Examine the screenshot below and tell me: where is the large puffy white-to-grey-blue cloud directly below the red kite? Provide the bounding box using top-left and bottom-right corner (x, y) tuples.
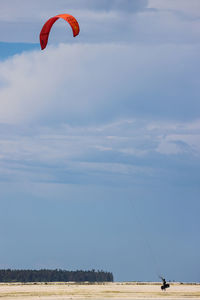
(0, 44), (199, 124)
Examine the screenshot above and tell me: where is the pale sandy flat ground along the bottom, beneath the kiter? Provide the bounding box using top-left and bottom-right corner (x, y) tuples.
(0, 282), (200, 300)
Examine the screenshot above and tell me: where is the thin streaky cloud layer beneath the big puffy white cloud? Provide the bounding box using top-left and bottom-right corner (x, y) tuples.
(0, 119), (200, 183)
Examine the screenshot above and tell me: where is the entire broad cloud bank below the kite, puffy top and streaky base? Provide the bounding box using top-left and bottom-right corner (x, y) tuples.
(0, 44), (200, 185)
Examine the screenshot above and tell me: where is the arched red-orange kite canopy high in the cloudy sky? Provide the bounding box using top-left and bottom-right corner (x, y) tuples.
(40, 14), (80, 50)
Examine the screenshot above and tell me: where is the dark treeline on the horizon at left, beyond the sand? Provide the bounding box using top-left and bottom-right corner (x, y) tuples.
(0, 269), (114, 282)
